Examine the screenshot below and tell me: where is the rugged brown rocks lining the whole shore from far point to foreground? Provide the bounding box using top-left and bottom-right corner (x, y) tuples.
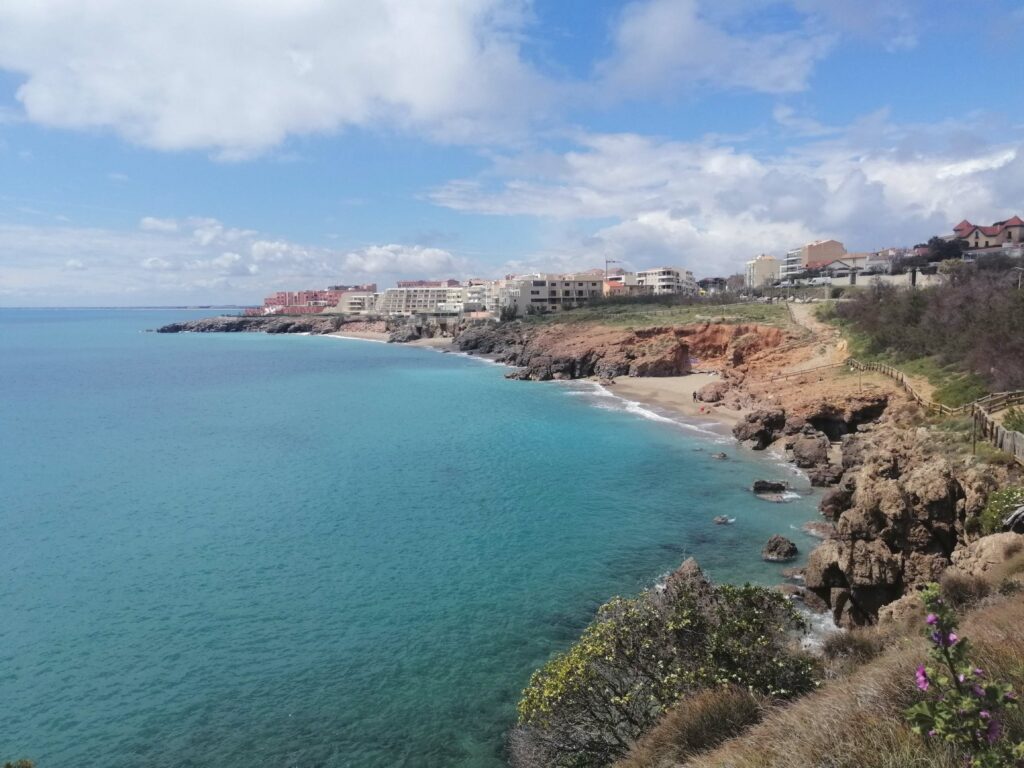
(158, 315), (1013, 628)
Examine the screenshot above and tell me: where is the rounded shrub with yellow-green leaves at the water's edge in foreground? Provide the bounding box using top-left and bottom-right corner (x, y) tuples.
(511, 567), (817, 768)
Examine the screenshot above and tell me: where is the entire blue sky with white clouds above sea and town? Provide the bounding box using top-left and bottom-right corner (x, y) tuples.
(0, 0), (1024, 306)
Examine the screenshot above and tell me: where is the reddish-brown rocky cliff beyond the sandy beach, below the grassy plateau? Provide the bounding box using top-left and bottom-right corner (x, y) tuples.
(456, 323), (785, 381)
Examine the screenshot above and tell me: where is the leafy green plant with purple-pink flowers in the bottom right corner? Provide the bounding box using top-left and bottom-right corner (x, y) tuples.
(906, 585), (1024, 768)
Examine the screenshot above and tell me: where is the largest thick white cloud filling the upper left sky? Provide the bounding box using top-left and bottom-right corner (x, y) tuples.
(0, 0), (548, 158)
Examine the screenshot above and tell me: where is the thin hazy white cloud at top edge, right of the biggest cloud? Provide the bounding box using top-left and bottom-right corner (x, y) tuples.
(598, 0), (831, 95)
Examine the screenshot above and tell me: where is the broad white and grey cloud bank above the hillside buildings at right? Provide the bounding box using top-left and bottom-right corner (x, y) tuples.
(432, 115), (1024, 274)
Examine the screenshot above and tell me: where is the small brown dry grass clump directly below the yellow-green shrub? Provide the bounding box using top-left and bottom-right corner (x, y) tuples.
(615, 688), (762, 768)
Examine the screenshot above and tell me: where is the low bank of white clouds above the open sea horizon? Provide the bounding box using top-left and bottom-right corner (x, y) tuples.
(0, 218), (465, 306)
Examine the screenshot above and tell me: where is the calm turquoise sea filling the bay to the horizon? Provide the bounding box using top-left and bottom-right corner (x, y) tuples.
(0, 310), (815, 768)
